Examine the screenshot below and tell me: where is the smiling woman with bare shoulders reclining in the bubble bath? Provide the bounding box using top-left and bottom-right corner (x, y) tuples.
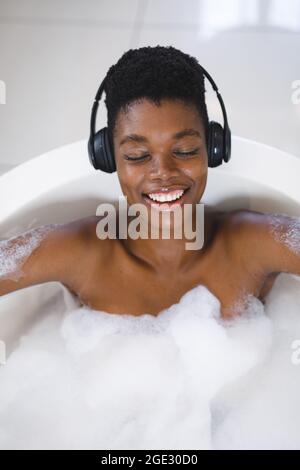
(0, 46), (300, 318)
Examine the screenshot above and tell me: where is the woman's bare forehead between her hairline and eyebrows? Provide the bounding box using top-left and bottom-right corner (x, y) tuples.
(115, 99), (202, 140)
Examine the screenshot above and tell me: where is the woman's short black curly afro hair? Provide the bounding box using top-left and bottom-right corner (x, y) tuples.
(104, 46), (209, 148)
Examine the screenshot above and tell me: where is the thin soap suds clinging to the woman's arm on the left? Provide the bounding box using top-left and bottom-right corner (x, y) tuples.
(0, 224), (57, 281)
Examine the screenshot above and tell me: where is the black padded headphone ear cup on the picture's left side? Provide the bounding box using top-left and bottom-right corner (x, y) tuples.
(89, 127), (116, 173)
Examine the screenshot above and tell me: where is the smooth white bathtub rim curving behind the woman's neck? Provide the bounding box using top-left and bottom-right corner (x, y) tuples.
(0, 136), (300, 222)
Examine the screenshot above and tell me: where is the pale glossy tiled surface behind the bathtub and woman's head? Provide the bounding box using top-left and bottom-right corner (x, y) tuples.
(0, 0), (300, 172)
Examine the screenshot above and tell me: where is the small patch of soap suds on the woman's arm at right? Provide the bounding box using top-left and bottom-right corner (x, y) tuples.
(270, 214), (300, 255)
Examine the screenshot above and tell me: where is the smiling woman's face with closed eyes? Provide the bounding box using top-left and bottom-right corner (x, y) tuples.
(114, 99), (207, 208)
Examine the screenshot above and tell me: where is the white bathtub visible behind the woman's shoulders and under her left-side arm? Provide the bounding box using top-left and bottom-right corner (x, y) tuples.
(0, 137), (300, 353)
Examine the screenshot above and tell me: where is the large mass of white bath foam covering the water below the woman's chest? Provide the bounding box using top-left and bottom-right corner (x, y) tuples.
(0, 273), (300, 449)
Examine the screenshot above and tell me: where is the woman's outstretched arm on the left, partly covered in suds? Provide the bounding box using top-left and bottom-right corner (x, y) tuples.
(0, 220), (88, 296)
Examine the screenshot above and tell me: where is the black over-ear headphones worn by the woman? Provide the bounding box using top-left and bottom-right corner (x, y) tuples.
(88, 65), (231, 173)
